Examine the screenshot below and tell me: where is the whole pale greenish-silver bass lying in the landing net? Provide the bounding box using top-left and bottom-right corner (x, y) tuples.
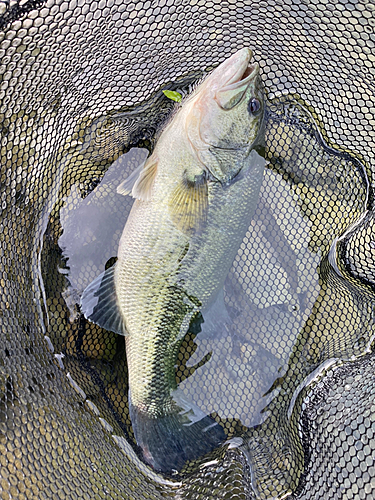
(81, 48), (266, 474)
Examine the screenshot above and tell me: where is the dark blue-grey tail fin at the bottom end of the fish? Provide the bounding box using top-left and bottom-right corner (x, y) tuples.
(129, 391), (226, 473)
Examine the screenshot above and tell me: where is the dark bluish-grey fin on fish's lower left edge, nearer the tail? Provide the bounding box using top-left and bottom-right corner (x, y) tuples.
(81, 266), (126, 335)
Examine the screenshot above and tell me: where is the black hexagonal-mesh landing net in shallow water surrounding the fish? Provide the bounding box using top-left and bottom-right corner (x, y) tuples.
(0, 0), (375, 500)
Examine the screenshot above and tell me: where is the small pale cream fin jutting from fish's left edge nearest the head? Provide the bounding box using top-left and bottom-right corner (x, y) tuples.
(117, 154), (158, 201)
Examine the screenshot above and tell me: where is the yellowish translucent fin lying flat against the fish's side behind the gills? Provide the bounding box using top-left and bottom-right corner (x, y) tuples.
(169, 171), (208, 235)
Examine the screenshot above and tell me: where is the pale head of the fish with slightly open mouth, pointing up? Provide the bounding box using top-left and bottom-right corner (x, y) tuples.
(185, 48), (264, 183)
